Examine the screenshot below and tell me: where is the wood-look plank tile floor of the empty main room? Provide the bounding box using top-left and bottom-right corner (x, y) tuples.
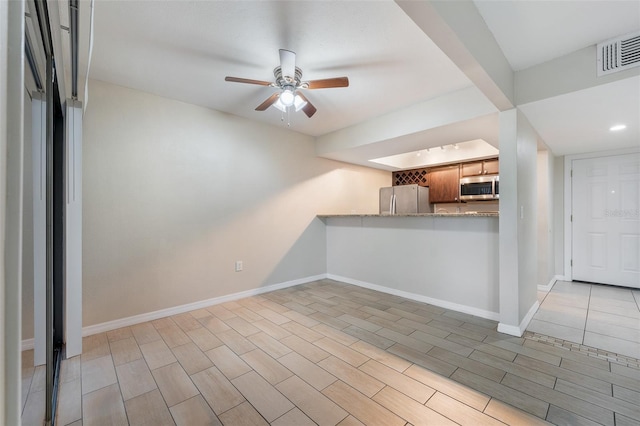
(23, 280), (640, 426)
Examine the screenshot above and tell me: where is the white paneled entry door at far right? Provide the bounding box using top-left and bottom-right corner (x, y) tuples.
(571, 153), (640, 288)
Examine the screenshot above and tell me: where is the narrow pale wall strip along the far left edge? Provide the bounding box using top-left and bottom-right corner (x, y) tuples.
(0, 1), (24, 425)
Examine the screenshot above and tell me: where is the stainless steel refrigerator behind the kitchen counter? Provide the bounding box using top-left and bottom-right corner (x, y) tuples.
(380, 185), (433, 215)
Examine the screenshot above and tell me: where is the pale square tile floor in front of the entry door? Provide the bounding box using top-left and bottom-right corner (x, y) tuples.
(527, 281), (640, 358)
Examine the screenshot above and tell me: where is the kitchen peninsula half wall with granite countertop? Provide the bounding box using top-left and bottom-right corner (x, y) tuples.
(318, 212), (499, 320)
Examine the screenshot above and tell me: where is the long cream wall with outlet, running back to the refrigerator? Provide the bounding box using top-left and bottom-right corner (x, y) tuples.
(83, 81), (391, 327)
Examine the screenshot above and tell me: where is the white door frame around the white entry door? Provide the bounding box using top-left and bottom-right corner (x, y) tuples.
(563, 148), (640, 281)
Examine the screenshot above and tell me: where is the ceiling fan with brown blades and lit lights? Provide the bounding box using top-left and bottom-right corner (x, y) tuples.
(224, 49), (349, 118)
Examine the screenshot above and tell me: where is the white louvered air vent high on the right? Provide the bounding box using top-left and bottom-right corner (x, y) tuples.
(598, 33), (640, 77)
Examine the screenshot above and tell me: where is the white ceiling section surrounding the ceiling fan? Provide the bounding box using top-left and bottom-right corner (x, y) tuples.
(91, 1), (471, 136)
